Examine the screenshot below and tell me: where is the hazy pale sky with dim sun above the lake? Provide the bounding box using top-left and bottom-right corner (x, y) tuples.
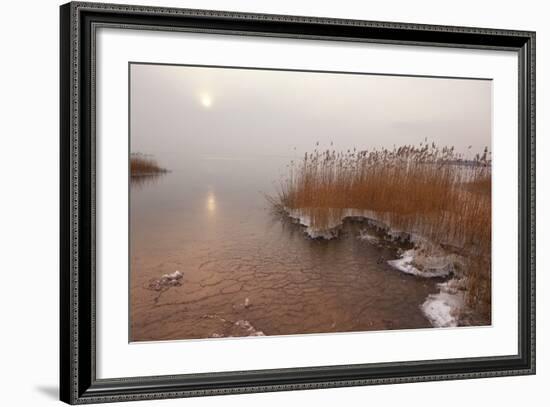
(130, 64), (492, 167)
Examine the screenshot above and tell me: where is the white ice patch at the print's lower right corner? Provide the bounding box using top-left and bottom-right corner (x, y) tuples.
(420, 279), (464, 328)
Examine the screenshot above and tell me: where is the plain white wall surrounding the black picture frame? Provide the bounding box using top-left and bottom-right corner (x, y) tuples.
(0, 0), (550, 407)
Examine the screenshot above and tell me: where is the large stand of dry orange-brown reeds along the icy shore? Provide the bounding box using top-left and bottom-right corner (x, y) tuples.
(275, 140), (491, 315)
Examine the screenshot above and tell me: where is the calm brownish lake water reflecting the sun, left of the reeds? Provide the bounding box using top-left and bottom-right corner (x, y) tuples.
(130, 157), (438, 341)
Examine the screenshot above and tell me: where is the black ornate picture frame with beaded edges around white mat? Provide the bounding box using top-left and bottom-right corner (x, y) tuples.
(60, 2), (535, 404)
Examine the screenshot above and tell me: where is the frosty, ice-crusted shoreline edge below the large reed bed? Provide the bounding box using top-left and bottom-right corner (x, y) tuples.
(284, 208), (465, 327)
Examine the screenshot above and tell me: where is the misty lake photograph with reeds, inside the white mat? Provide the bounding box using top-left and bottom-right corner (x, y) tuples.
(128, 61), (493, 342)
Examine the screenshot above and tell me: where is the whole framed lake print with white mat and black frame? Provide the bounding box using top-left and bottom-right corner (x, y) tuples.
(60, 2), (535, 404)
